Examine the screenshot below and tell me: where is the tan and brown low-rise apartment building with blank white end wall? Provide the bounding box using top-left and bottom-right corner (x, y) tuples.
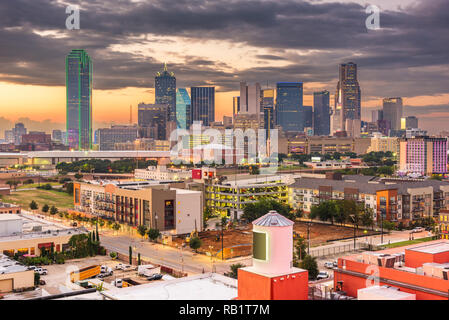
(74, 182), (203, 235)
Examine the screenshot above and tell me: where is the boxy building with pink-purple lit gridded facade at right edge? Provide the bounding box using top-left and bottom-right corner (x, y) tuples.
(399, 136), (448, 176)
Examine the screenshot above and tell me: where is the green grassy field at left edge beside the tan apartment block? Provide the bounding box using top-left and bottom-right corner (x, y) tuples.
(2, 190), (73, 210)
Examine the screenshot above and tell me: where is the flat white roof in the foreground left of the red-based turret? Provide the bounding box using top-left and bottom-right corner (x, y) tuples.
(102, 273), (238, 300)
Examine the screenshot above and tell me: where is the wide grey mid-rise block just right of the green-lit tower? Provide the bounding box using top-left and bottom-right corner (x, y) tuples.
(98, 125), (137, 151)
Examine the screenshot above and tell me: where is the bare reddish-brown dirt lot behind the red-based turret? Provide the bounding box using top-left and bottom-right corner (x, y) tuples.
(173, 222), (371, 254)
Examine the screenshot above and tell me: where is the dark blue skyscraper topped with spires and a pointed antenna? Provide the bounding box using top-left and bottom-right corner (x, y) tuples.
(154, 64), (176, 121)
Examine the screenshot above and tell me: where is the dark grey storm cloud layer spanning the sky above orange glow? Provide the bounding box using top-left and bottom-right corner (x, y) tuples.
(0, 0), (449, 98)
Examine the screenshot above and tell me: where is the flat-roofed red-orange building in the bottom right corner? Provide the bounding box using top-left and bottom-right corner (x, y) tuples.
(334, 240), (449, 300)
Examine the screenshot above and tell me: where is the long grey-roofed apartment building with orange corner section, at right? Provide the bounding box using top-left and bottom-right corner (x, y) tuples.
(289, 174), (449, 225)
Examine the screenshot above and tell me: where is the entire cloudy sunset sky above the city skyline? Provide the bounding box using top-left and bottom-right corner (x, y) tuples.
(0, 0), (449, 137)
